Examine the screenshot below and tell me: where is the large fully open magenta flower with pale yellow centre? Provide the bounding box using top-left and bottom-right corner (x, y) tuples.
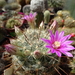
(42, 31), (75, 57)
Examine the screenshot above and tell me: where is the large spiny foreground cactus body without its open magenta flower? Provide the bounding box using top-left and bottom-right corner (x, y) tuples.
(4, 27), (60, 75)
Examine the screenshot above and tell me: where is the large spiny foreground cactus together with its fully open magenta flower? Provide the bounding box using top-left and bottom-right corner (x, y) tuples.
(5, 21), (74, 75)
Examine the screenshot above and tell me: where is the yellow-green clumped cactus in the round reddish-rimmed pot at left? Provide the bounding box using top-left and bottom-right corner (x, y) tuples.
(5, 18), (21, 29)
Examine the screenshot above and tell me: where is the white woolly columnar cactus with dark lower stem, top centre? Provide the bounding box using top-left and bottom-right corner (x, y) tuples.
(30, 0), (47, 28)
